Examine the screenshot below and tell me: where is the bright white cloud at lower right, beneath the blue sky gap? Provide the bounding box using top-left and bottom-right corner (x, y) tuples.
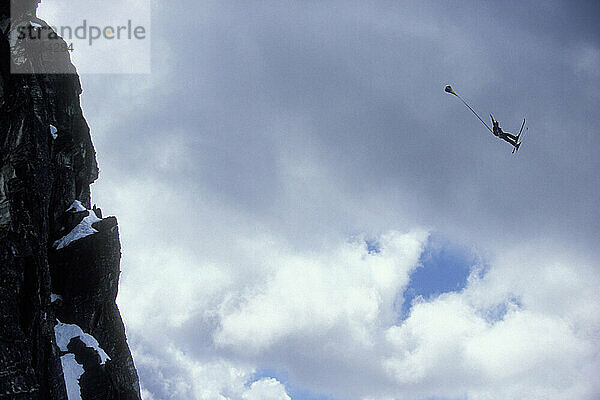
(385, 247), (600, 399)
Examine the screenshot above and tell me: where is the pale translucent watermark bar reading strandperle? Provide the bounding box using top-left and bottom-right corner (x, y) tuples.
(9, 0), (151, 74)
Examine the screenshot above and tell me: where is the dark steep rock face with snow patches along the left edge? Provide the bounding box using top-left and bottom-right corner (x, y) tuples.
(0, 0), (140, 400)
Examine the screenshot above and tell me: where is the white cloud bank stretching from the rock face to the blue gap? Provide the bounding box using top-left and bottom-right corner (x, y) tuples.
(119, 223), (427, 399)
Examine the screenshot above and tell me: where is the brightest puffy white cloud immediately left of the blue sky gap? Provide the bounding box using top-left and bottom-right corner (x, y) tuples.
(216, 232), (426, 352)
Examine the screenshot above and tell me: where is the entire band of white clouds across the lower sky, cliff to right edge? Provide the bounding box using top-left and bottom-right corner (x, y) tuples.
(105, 188), (600, 400)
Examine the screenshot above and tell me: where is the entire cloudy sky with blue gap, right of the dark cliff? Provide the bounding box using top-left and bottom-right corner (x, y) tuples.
(40, 0), (600, 400)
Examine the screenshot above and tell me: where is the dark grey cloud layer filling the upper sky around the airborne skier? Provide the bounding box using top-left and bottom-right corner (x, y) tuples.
(84, 2), (600, 251)
